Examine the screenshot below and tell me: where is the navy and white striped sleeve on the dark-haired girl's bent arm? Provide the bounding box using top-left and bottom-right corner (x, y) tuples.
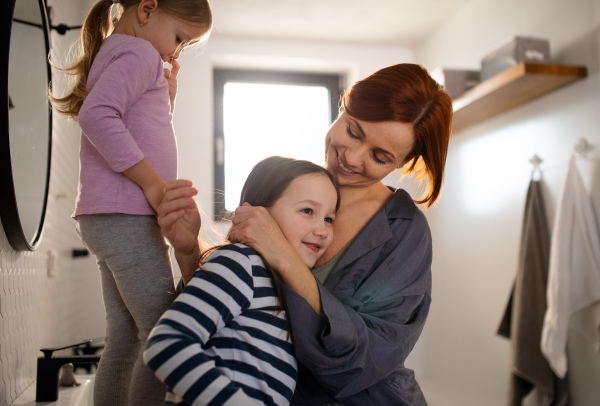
(144, 245), (259, 406)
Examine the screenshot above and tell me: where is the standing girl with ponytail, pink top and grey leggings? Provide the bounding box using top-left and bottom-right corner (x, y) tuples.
(50, 0), (212, 406)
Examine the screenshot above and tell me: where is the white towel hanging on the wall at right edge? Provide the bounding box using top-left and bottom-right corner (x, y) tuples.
(541, 157), (600, 378)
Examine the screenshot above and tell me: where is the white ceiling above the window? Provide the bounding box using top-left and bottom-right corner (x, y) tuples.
(210, 0), (470, 47)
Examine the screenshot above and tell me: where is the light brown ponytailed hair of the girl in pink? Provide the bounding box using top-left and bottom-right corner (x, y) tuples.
(48, 0), (212, 121)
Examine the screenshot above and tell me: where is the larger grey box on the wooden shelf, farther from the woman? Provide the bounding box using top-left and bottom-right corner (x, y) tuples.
(481, 36), (550, 81)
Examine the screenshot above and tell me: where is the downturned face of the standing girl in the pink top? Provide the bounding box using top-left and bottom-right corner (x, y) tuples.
(135, 8), (207, 62)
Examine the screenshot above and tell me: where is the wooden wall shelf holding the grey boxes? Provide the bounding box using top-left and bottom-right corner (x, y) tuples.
(452, 62), (587, 132)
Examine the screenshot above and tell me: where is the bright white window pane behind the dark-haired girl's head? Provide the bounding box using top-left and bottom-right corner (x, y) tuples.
(223, 83), (331, 210)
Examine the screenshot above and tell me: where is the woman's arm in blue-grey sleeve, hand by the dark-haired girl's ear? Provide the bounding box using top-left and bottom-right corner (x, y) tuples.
(233, 195), (431, 399)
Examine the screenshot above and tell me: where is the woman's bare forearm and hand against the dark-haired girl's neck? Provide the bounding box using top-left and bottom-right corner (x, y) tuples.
(229, 203), (325, 317)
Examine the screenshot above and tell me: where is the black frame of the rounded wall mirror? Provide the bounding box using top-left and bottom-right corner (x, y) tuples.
(0, 0), (52, 251)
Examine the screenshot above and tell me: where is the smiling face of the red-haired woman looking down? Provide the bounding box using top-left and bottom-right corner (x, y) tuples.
(325, 112), (415, 187)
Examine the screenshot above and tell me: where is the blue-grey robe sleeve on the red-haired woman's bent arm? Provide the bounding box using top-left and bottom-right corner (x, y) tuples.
(287, 190), (432, 405)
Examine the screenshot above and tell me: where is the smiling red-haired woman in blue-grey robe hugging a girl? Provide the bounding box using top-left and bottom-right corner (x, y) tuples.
(159, 64), (452, 406)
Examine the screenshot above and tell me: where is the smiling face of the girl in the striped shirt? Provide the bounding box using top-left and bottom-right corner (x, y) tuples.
(267, 173), (337, 268)
